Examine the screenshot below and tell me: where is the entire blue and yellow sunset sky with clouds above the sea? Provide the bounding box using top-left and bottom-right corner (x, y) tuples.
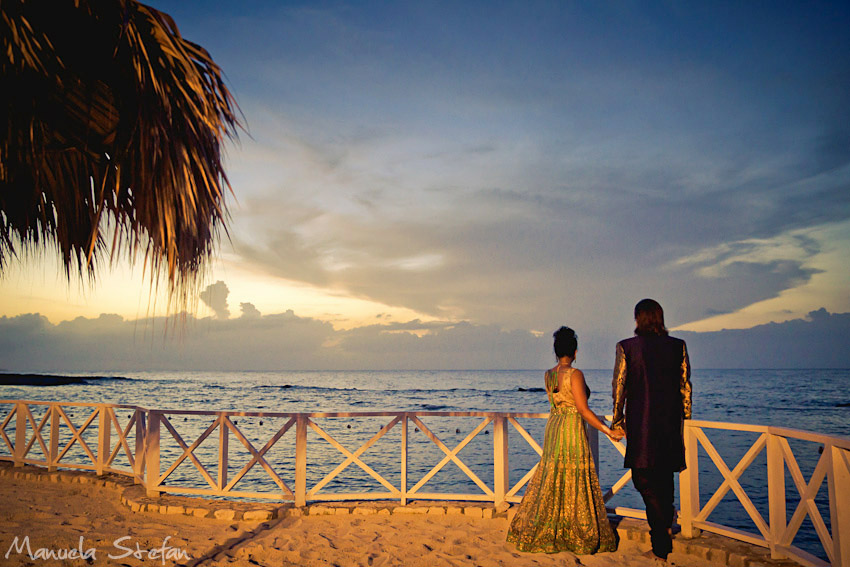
(0, 0), (850, 369)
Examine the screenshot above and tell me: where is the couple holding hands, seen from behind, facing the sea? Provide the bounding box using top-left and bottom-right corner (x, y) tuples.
(507, 299), (691, 561)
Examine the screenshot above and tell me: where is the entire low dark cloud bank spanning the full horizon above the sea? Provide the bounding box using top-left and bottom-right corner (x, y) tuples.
(0, 304), (850, 372)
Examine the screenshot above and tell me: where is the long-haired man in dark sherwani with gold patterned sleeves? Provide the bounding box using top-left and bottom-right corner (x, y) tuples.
(611, 299), (691, 561)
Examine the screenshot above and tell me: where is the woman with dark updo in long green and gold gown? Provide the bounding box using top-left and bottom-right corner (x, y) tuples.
(508, 327), (623, 554)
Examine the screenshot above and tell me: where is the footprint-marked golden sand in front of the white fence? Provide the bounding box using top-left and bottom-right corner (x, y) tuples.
(0, 463), (796, 567)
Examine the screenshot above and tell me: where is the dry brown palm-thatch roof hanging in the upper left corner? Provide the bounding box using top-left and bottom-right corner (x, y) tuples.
(0, 0), (239, 304)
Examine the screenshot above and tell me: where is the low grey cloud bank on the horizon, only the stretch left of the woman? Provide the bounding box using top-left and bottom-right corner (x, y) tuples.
(0, 310), (549, 373)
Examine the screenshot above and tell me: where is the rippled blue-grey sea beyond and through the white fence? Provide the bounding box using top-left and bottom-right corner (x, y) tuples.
(0, 369), (850, 555)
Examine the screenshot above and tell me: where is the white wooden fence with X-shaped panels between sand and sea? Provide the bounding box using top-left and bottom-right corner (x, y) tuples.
(0, 400), (850, 567)
